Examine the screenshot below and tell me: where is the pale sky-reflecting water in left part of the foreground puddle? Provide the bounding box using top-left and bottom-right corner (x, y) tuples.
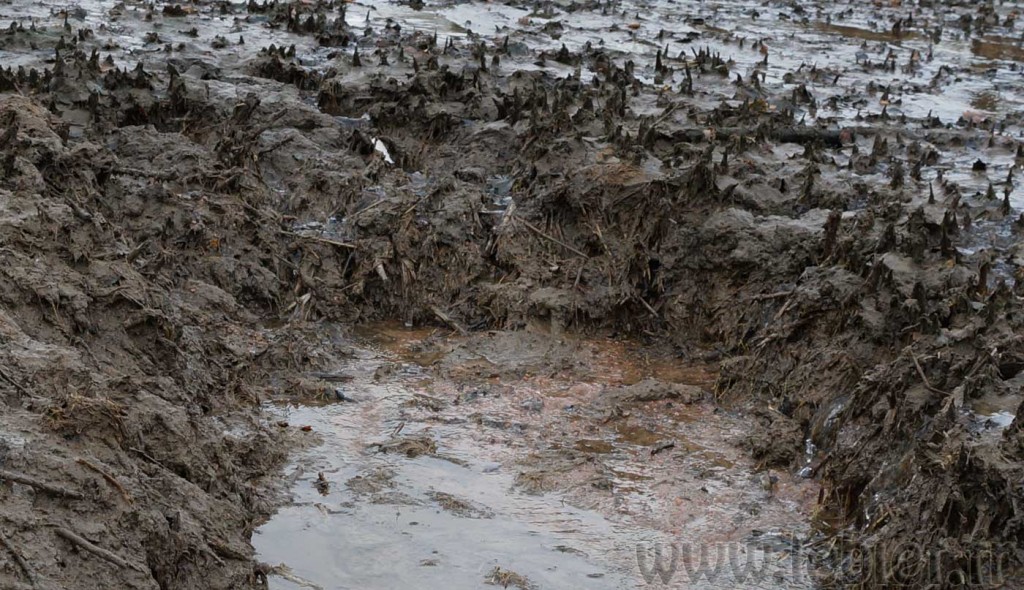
(253, 344), (643, 588)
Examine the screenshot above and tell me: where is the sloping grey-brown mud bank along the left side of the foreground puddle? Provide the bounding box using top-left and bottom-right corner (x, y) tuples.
(0, 91), (339, 588)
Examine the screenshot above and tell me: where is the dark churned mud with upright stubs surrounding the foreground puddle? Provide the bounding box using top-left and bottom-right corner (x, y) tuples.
(0, 2), (1024, 588)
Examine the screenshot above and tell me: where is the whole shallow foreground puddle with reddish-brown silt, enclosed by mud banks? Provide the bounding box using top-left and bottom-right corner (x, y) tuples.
(253, 326), (816, 589)
